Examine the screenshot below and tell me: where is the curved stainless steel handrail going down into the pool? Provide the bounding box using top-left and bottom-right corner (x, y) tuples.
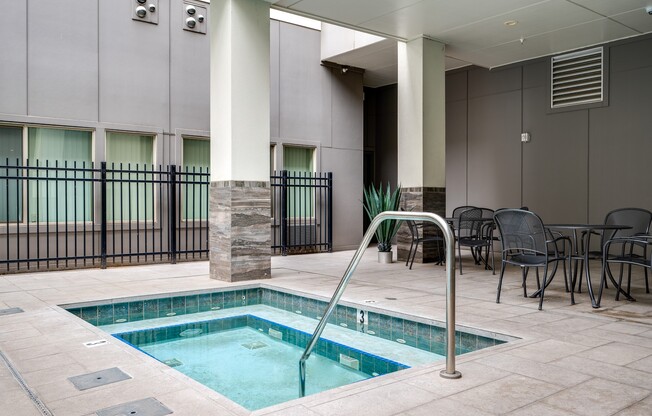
(299, 211), (462, 397)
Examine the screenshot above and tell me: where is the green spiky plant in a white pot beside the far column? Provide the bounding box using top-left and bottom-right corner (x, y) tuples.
(363, 183), (402, 252)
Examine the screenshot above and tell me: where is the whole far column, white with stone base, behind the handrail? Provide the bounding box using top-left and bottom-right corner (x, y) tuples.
(398, 37), (446, 262)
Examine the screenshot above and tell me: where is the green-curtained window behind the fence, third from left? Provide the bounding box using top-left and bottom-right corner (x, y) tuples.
(106, 131), (155, 221)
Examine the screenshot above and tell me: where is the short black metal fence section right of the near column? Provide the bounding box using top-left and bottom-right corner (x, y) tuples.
(270, 170), (333, 255)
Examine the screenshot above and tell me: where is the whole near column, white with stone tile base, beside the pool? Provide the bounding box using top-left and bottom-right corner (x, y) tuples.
(209, 0), (271, 281)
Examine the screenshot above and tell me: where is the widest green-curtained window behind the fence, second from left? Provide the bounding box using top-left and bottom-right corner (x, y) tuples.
(27, 127), (93, 222)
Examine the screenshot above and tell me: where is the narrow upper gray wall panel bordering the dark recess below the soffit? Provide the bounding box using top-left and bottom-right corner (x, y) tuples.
(331, 68), (363, 150)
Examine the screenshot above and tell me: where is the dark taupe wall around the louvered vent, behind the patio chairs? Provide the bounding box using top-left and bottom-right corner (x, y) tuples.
(446, 36), (652, 222)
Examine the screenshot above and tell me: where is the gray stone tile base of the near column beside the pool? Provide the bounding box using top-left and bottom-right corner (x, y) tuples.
(208, 181), (271, 282)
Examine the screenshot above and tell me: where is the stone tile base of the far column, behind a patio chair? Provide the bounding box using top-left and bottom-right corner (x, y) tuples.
(396, 187), (446, 263)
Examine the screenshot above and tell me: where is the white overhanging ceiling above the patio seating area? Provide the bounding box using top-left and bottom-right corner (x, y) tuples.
(268, 0), (652, 86)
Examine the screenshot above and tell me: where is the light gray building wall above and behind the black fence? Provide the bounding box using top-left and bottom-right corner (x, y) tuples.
(0, 0), (362, 254)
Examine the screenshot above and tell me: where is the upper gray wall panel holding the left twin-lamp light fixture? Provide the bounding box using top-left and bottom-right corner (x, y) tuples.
(99, 0), (170, 128)
